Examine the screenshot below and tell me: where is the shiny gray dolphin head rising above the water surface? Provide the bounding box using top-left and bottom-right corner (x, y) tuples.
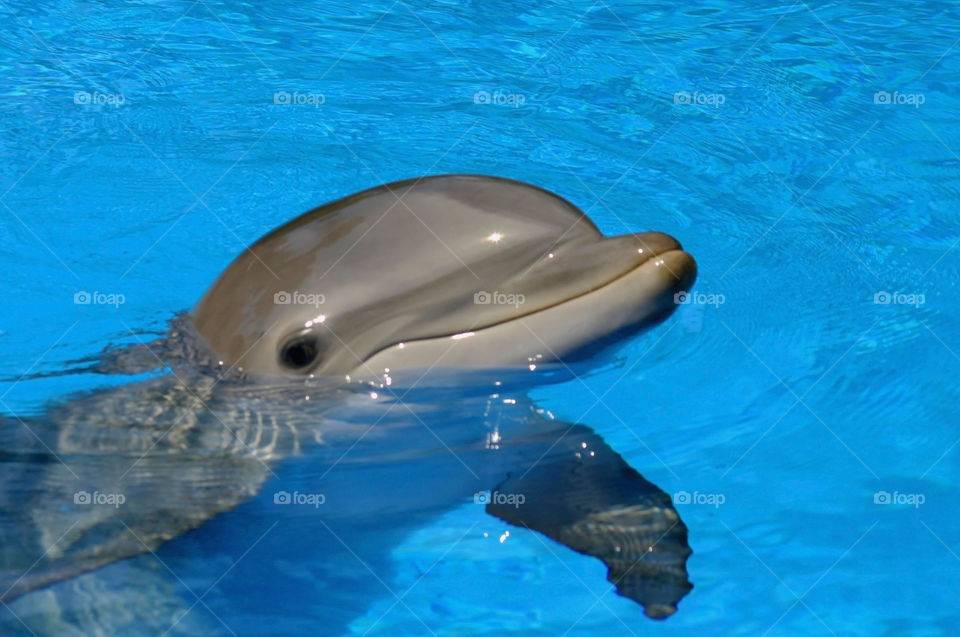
(192, 175), (696, 376)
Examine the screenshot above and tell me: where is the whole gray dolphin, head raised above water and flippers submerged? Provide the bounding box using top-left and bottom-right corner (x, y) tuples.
(0, 175), (696, 632)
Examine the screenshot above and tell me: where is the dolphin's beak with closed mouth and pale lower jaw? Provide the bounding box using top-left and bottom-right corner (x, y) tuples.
(354, 232), (697, 371)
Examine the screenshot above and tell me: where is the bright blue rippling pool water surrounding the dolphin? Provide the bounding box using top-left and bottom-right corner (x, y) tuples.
(0, 0), (960, 635)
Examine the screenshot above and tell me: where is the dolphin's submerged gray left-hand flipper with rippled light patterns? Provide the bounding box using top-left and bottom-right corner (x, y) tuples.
(0, 377), (295, 602)
